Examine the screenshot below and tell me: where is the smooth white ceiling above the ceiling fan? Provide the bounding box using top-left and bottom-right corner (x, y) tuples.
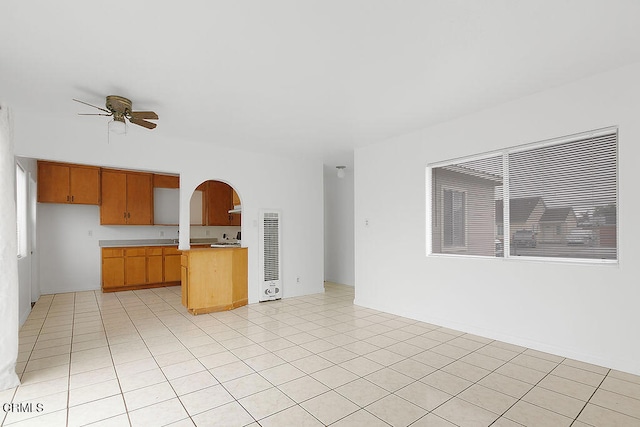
(0, 0), (640, 164)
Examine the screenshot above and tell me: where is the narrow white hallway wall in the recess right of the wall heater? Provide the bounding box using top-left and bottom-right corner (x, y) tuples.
(324, 165), (355, 286)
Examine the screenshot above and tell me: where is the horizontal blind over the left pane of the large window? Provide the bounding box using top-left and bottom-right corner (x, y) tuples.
(431, 155), (502, 256)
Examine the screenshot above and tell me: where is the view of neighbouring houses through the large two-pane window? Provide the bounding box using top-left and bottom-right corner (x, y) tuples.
(427, 128), (618, 262)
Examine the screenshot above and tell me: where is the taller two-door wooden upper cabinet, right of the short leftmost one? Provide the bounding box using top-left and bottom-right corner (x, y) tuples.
(100, 169), (153, 225)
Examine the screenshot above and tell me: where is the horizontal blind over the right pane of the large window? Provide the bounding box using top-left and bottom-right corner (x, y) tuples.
(508, 131), (617, 260)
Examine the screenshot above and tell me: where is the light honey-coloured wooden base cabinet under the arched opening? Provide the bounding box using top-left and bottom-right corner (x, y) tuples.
(182, 248), (248, 314)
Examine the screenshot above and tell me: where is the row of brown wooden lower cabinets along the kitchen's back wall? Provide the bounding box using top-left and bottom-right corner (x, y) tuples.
(102, 246), (180, 292)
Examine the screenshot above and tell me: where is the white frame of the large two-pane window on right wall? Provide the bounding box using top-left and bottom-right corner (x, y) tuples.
(425, 126), (620, 266)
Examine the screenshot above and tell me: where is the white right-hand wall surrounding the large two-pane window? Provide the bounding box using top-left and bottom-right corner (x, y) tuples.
(355, 64), (640, 374)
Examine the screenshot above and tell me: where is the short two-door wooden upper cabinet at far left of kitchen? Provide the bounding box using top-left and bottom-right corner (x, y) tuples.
(38, 162), (100, 205)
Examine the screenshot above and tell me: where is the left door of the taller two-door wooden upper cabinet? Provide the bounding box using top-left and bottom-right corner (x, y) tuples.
(100, 170), (127, 225)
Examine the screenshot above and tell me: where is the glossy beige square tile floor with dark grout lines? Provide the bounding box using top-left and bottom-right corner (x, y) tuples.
(0, 283), (640, 427)
